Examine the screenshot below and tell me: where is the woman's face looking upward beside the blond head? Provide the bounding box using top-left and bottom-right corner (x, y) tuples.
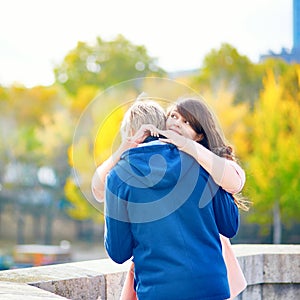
(166, 108), (200, 141)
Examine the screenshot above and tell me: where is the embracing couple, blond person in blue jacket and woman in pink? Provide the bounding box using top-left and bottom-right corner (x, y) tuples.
(92, 98), (247, 300)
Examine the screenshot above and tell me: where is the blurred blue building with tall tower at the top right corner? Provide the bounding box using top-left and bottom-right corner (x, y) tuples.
(260, 0), (300, 63)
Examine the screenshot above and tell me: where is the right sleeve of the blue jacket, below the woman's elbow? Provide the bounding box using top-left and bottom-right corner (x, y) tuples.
(213, 188), (240, 238)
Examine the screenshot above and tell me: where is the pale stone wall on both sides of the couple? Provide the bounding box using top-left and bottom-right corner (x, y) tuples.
(0, 245), (300, 300)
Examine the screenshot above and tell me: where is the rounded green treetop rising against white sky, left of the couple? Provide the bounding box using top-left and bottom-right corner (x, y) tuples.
(54, 35), (164, 95)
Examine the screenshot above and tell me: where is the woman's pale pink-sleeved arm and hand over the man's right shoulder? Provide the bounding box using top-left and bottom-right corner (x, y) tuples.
(158, 130), (245, 194)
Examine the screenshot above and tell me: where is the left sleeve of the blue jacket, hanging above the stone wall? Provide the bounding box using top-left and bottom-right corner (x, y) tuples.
(104, 173), (133, 264)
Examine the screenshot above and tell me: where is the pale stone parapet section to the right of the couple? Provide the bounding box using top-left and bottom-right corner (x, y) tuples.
(233, 245), (300, 300)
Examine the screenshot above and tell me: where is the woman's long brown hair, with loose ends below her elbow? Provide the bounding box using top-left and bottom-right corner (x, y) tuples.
(175, 98), (249, 210)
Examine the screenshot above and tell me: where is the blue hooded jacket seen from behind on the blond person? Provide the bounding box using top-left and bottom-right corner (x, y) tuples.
(105, 141), (239, 300)
